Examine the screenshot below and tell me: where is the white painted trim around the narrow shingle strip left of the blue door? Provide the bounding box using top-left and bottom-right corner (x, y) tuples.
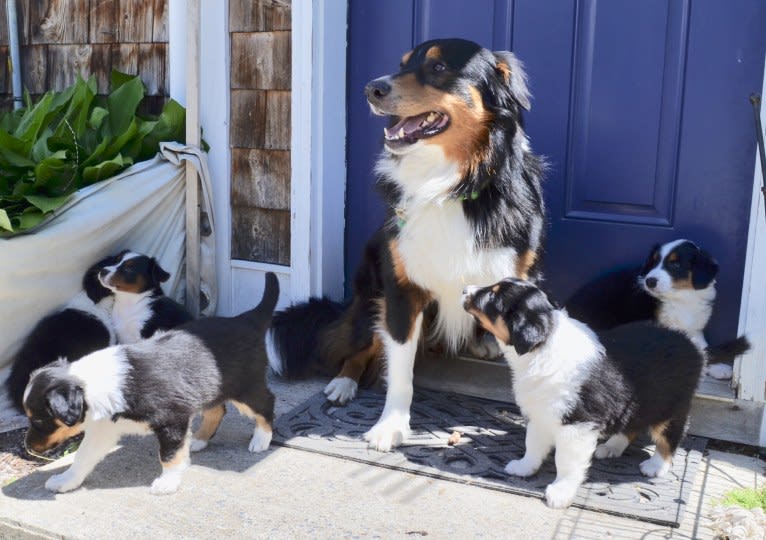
(168, 0), (348, 315)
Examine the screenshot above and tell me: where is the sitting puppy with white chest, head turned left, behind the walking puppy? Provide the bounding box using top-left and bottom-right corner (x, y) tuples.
(99, 251), (192, 343)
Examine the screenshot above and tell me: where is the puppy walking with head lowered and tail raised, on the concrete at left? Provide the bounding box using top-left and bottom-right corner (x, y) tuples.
(24, 273), (279, 494)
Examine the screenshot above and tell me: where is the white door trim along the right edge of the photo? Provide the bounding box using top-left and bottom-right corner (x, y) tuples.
(735, 56), (766, 410)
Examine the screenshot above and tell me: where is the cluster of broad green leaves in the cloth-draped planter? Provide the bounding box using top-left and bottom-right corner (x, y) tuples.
(0, 71), (186, 234)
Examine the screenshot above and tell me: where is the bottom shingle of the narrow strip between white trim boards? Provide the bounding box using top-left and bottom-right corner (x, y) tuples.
(231, 206), (290, 265)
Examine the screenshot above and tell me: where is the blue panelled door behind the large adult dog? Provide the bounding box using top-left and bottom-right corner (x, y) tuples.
(346, 0), (766, 342)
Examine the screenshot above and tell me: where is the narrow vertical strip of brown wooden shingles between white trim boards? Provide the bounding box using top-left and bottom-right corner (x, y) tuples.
(229, 0), (292, 265)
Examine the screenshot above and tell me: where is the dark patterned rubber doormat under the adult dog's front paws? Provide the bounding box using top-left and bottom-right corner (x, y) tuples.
(273, 389), (707, 527)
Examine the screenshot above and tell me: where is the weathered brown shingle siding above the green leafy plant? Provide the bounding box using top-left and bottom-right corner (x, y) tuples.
(0, 0), (169, 113)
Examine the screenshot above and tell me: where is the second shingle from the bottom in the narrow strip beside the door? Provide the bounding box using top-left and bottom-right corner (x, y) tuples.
(231, 148), (290, 210)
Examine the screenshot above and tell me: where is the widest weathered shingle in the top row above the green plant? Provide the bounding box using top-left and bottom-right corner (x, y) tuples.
(29, 0), (90, 45)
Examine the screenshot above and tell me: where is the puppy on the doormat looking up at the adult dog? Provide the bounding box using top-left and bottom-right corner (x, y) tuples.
(463, 279), (704, 508)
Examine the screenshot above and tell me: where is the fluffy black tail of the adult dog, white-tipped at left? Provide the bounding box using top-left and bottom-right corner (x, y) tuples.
(266, 298), (345, 379)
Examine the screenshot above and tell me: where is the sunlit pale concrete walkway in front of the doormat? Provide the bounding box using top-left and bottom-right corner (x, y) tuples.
(0, 380), (764, 540)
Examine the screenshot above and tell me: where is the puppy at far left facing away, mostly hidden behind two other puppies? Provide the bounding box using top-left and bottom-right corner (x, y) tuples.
(5, 257), (116, 411)
